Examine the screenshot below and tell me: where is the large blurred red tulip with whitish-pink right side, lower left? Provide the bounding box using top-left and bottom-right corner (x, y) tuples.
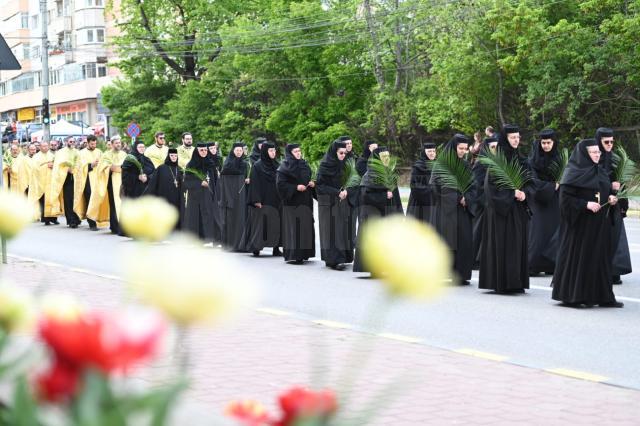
(39, 311), (165, 374)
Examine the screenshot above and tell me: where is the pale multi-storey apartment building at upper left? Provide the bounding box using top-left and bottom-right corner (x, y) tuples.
(0, 0), (118, 131)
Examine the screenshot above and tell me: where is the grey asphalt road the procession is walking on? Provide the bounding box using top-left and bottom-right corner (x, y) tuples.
(9, 219), (640, 389)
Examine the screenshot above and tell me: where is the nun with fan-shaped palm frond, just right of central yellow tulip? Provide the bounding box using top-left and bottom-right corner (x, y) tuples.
(431, 133), (473, 285)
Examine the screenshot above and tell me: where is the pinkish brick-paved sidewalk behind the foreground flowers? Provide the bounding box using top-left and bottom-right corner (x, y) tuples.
(2, 258), (640, 426)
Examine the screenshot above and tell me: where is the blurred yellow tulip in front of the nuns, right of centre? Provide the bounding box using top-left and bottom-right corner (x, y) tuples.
(361, 215), (451, 299)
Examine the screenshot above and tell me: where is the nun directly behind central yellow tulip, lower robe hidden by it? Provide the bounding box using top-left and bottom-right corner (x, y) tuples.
(353, 146), (404, 272)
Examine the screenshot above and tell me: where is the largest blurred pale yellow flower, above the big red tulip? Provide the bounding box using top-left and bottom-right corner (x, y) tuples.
(125, 242), (256, 326)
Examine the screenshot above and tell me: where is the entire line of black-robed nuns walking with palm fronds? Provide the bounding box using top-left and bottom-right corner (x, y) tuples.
(115, 125), (631, 307)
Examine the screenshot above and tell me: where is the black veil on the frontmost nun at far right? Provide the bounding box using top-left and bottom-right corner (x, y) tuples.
(560, 139), (608, 191)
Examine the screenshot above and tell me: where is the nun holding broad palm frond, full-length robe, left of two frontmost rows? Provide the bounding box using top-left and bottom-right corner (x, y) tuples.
(478, 125), (530, 294)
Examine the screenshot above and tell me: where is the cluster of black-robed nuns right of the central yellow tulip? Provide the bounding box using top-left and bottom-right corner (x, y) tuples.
(408, 125), (631, 308)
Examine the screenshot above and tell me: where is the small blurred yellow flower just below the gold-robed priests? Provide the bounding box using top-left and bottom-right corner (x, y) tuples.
(120, 195), (178, 241)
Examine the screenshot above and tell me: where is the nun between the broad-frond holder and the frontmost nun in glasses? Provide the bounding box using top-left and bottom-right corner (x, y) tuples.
(528, 129), (560, 275)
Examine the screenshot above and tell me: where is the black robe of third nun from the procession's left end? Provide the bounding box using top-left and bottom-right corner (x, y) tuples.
(180, 171), (213, 242)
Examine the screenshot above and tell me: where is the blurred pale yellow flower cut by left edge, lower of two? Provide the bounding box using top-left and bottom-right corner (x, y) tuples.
(0, 283), (36, 333)
